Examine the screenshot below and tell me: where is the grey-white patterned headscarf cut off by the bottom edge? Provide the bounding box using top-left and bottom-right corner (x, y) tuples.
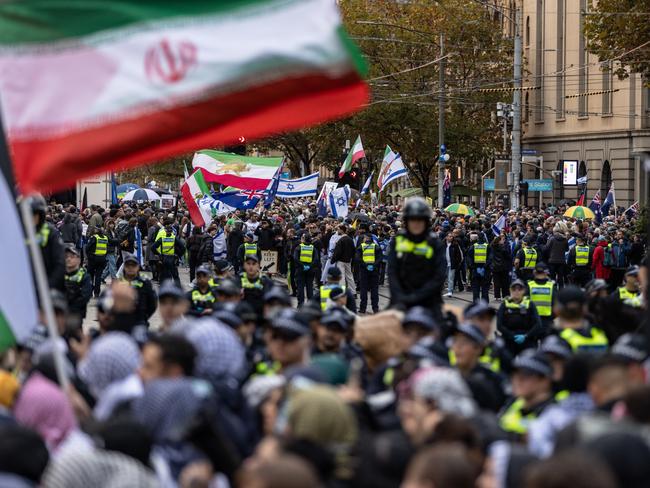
(43, 449), (159, 488)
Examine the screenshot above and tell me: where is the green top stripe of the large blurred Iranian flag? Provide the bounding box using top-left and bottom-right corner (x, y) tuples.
(0, 0), (278, 45)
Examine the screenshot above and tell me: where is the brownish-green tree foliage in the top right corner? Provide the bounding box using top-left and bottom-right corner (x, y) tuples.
(584, 0), (650, 83)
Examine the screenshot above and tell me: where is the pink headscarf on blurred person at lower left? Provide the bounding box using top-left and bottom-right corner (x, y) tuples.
(14, 373), (77, 451)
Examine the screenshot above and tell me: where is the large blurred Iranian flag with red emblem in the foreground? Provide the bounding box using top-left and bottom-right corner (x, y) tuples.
(0, 0), (368, 191)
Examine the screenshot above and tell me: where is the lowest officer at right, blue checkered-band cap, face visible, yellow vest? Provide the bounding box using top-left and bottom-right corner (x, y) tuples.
(499, 349), (554, 440)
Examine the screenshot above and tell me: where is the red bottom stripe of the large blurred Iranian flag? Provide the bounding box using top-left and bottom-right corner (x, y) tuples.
(10, 73), (368, 192)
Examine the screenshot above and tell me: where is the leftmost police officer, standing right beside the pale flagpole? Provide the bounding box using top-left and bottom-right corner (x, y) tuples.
(31, 195), (65, 292)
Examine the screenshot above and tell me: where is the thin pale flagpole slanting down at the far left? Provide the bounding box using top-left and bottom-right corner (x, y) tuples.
(20, 197), (70, 394)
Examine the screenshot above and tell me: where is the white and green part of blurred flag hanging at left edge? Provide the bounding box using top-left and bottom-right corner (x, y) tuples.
(0, 168), (38, 352)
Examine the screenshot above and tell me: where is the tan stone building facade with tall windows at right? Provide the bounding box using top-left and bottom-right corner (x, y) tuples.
(508, 0), (650, 206)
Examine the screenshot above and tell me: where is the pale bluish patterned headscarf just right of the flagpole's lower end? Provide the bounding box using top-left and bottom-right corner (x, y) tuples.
(78, 332), (140, 398)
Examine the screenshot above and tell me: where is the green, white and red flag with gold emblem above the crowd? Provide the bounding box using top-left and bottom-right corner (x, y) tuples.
(192, 149), (283, 190)
